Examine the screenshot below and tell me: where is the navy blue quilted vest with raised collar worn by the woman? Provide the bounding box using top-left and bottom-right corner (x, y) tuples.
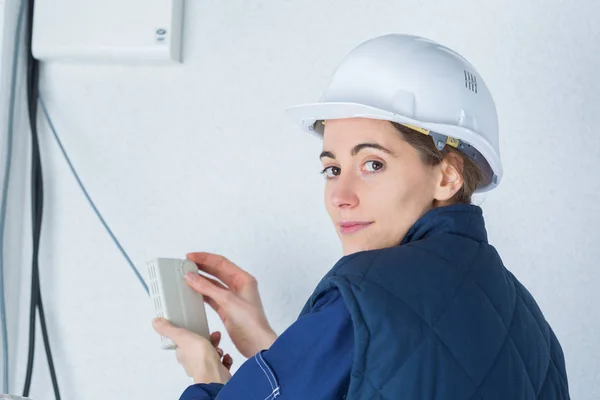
(300, 204), (569, 400)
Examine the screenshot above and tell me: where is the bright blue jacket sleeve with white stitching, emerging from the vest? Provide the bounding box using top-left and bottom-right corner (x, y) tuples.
(180, 288), (354, 400)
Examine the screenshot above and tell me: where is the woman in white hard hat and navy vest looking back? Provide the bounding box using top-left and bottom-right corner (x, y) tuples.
(154, 35), (569, 400)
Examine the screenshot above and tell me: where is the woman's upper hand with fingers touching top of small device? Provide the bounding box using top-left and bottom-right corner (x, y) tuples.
(186, 252), (277, 358)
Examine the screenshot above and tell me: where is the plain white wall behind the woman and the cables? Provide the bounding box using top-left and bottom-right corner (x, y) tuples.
(2, 0), (600, 400)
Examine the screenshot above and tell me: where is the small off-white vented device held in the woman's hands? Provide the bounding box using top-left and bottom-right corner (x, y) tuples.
(147, 258), (210, 349)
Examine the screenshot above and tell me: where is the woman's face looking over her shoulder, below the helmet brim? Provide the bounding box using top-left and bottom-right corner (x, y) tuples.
(321, 118), (441, 255)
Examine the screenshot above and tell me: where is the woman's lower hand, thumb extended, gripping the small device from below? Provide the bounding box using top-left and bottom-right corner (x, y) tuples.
(152, 318), (232, 384)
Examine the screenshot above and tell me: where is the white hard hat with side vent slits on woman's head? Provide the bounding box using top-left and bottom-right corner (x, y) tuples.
(286, 34), (502, 192)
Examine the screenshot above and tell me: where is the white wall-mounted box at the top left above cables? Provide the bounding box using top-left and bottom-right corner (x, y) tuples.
(32, 0), (183, 63)
